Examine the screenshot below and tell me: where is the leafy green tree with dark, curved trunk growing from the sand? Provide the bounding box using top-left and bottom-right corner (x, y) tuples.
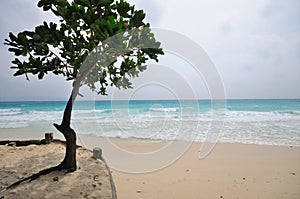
(5, 0), (163, 172)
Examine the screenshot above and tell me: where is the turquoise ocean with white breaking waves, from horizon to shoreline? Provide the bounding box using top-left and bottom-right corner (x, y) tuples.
(0, 99), (300, 146)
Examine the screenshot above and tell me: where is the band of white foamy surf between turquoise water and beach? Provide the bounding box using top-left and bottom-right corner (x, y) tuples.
(0, 102), (300, 145)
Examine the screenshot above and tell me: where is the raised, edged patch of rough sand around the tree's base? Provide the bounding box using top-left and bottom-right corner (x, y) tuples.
(0, 143), (112, 199)
